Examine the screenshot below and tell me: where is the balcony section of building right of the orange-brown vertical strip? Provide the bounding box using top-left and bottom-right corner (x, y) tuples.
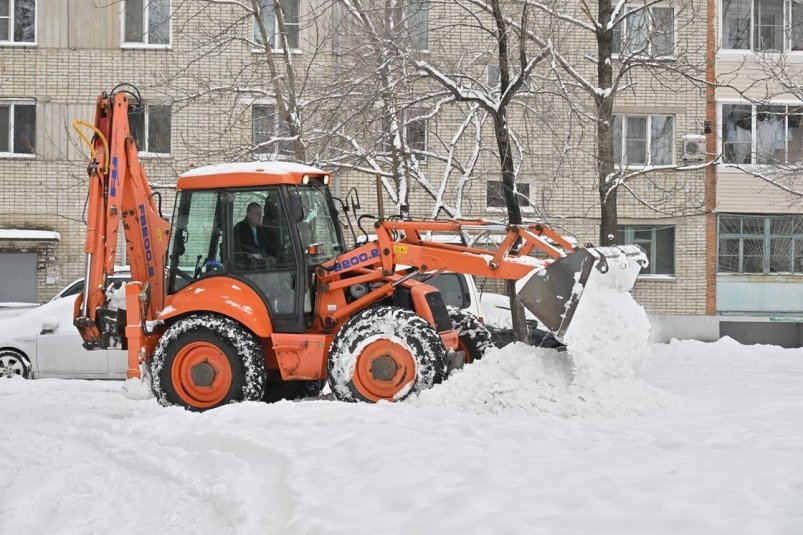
(715, 0), (803, 346)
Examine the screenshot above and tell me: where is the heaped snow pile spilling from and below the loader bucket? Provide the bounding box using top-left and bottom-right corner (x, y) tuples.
(411, 276), (674, 418)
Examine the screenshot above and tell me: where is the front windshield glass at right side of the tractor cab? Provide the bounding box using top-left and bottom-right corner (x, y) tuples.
(293, 186), (343, 263)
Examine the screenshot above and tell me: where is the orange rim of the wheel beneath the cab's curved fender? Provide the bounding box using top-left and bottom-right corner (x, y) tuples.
(170, 342), (231, 409)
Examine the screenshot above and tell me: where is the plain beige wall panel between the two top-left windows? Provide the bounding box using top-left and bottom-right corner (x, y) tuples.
(64, 0), (118, 49)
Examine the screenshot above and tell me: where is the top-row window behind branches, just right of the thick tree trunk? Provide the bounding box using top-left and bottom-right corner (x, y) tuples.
(612, 6), (675, 57)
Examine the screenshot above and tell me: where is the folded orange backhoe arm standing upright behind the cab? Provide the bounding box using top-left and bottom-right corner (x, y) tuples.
(74, 91), (170, 349)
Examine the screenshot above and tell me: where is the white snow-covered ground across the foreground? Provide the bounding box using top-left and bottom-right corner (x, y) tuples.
(0, 339), (803, 535)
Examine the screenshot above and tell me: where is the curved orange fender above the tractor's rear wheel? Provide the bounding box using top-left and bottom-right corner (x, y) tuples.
(157, 277), (273, 338)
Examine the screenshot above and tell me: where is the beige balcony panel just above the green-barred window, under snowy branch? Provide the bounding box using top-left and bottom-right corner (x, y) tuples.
(716, 171), (800, 214)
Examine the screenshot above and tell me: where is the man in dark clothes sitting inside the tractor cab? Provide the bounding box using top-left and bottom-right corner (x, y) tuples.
(234, 202), (278, 271)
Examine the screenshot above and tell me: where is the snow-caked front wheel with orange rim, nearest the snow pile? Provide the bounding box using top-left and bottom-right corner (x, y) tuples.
(329, 306), (446, 403)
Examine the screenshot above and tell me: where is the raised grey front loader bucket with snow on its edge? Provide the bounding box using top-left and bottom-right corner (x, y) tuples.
(518, 245), (647, 339)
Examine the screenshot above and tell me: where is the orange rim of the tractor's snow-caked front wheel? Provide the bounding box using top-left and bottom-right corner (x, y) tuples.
(352, 338), (416, 401)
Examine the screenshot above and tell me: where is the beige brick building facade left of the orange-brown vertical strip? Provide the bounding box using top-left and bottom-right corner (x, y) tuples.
(0, 0), (712, 330)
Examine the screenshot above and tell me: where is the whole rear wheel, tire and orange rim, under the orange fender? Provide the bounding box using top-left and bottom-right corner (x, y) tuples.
(151, 314), (265, 411)
